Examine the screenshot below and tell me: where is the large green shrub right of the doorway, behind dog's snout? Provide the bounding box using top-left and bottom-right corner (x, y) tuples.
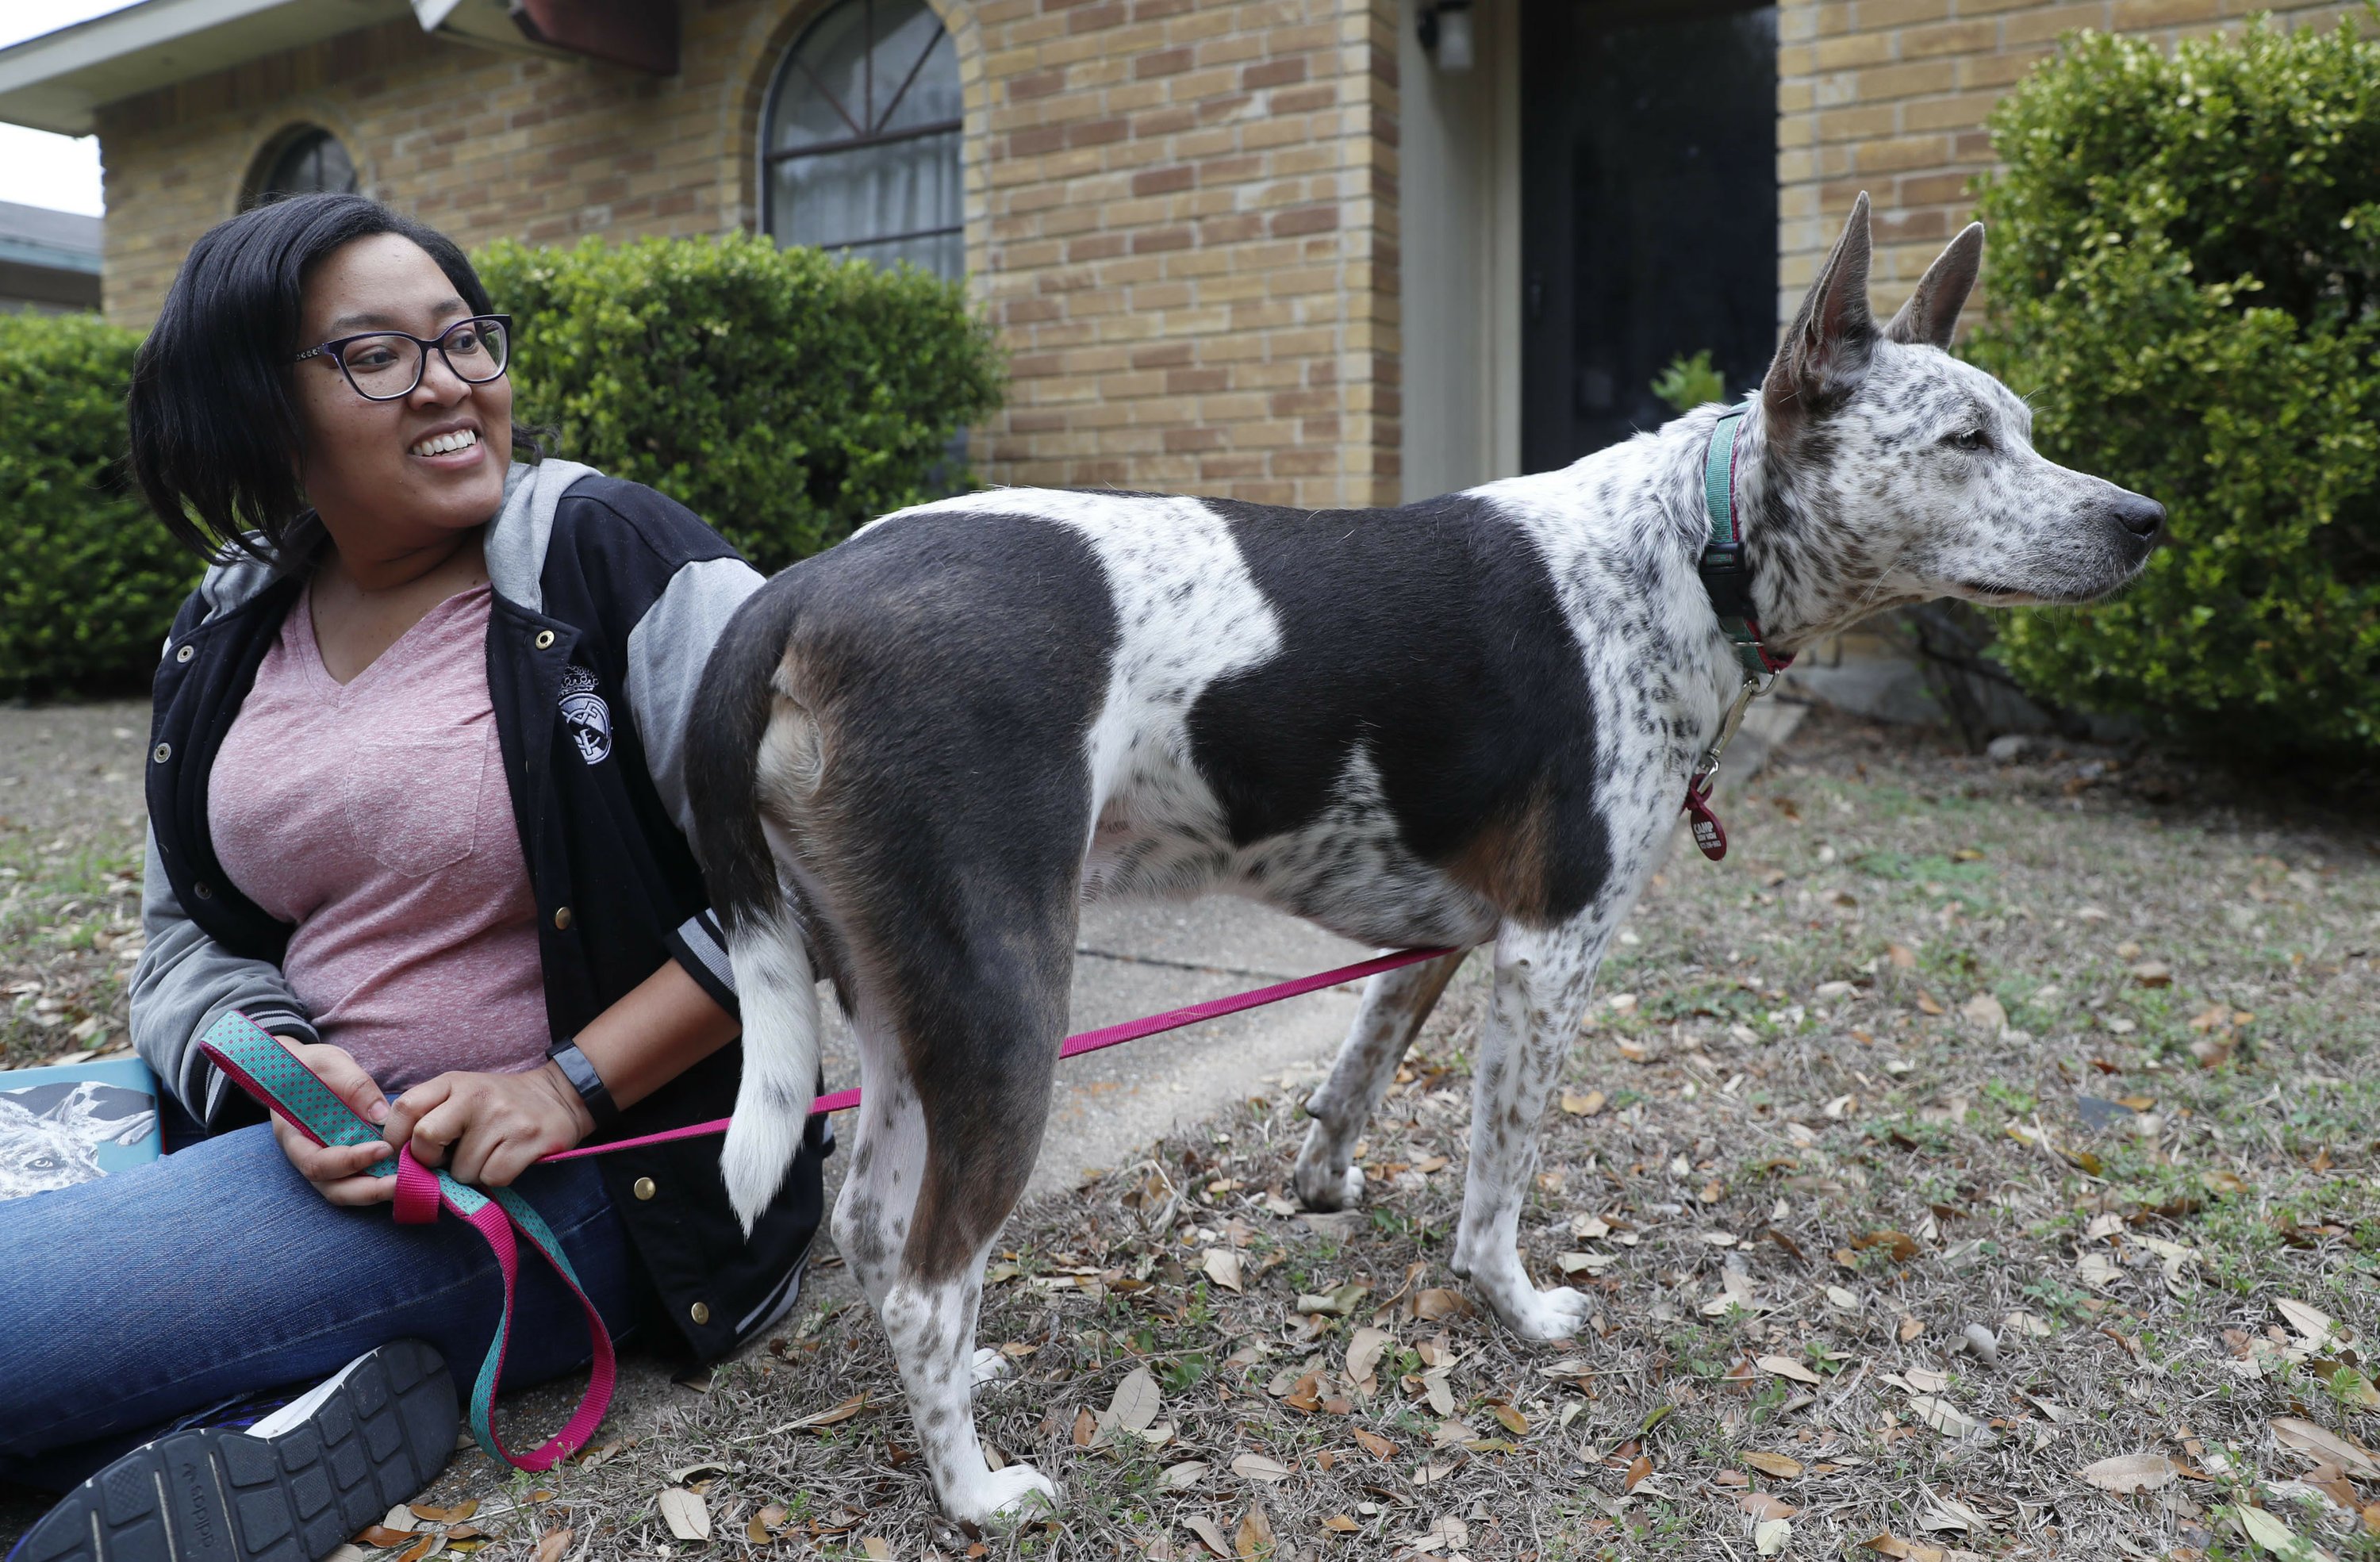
(1968, 24), (2380, 752)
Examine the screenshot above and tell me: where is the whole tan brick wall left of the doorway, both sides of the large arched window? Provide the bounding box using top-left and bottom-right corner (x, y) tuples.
(100, 0), (1397, 505)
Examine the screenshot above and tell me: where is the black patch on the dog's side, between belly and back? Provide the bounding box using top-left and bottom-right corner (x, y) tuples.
(1190, 495), (1611, 924)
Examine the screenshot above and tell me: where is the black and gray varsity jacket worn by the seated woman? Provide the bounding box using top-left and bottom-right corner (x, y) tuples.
(131, 462), (833, 1360)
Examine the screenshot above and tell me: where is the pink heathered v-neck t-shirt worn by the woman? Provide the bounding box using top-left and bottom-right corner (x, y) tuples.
(207, 585), (550, 1096)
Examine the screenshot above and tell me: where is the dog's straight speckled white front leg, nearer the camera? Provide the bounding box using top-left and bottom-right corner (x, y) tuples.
(1454, 928), (1611, 1341)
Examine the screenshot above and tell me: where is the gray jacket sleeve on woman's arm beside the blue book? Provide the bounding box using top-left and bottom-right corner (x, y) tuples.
(131, 831), (321, 1134)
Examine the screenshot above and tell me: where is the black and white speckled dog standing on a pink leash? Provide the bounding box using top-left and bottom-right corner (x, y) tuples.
(688, 198), (2163, 1519)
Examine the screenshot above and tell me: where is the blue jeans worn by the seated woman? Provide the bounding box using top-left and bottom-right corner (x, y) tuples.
(0, 1124), (638, 1491)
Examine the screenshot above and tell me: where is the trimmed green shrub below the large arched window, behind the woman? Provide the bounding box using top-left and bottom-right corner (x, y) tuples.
(478, 236), (1002, 569)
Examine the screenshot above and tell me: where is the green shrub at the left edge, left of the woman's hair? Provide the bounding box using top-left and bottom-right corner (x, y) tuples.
(0, 314), (200, 697)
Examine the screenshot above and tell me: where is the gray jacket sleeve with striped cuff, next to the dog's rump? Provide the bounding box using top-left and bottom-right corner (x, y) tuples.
(628, 557), (762, 1015)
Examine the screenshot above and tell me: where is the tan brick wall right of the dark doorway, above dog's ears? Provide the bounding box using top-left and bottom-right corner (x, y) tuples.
(1778, 0), (2359, 321)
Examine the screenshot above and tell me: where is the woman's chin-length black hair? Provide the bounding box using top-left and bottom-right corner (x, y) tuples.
(126, 195), (540, 566)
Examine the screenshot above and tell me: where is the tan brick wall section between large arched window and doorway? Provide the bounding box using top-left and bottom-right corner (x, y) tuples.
(978, 0), (1399, 505)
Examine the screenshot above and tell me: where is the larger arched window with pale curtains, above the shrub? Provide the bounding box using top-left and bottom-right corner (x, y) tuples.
(762, 0), (966, 276)
